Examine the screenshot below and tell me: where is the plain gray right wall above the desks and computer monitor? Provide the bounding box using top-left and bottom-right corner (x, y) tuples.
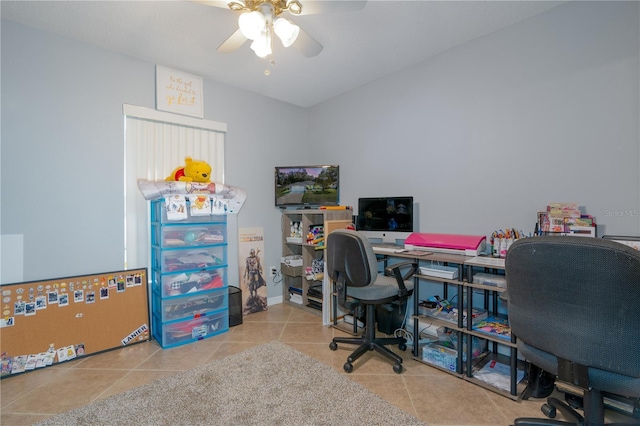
(308, 2), (640, 235)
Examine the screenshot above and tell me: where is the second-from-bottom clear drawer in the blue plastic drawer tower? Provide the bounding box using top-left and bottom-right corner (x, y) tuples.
(153, 287), (229, 322)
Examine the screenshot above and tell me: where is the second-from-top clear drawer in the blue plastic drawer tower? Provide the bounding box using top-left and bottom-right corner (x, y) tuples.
(152, 246), (227, 272)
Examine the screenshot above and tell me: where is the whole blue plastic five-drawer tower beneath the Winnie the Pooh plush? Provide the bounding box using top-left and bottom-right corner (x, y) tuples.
(151, 200), (229, 348)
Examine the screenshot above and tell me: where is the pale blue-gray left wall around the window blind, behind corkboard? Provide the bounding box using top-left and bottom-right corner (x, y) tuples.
(0, 20), (308, 297)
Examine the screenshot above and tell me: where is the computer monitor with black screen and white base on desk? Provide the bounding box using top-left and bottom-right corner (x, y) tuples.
(356, 197), (417, 244)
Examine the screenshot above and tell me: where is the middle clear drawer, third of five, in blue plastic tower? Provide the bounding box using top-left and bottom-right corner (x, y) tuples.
(153, 266), (227, 297)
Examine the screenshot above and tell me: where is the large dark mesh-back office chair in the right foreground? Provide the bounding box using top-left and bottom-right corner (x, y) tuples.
(505, 236), (640, 425)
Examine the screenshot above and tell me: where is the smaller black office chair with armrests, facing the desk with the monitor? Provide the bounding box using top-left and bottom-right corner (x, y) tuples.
(327, 229), (418, 374)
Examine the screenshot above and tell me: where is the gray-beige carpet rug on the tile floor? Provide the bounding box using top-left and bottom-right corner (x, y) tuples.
(37, 341), (424, 426)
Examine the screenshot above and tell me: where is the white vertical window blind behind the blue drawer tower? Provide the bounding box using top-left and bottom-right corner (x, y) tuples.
(123, 105), (227, 269)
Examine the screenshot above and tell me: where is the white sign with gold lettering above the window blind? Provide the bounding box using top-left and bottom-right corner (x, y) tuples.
(156, 65), (204, 118)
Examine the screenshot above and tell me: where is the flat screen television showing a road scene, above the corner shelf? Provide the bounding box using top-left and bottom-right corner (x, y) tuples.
(275, 165), (340, 208)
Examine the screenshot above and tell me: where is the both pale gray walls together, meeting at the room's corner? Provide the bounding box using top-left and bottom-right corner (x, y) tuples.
(0, 2), (640, 298)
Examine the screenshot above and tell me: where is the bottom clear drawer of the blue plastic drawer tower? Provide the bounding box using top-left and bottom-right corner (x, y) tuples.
(152, 309), (229, 348)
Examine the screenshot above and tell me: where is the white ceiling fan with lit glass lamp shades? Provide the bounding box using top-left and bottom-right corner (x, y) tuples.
(195, 0), (366, 58)
